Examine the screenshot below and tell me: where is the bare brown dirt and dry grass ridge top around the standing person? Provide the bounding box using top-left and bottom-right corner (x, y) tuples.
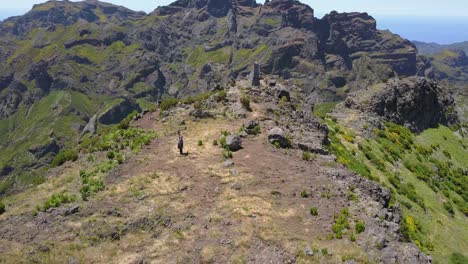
(0, 102), (368, 263)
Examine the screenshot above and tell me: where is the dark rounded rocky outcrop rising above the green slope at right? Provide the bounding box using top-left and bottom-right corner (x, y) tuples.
(345, 77), (456, 132)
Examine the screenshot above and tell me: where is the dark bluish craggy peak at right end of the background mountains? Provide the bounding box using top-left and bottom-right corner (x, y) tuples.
(318, 11), (417, 76)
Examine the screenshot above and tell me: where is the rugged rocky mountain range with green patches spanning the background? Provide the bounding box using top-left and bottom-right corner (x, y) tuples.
(0, 0), (416, 117)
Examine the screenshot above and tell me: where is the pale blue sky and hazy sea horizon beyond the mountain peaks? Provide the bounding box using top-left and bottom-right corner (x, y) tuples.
(0, 0), (468, 43)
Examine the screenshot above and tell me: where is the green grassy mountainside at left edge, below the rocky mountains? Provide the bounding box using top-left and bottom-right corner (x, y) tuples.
(0, 91), (102, 195)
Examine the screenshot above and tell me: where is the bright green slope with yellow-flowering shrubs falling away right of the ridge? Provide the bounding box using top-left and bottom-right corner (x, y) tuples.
(321, 99), (468, 263)
